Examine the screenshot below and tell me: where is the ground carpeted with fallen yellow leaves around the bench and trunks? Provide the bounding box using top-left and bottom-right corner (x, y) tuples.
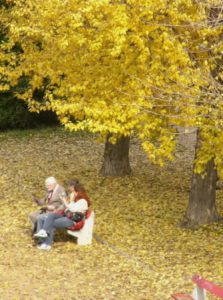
(0, 129), (223, 300)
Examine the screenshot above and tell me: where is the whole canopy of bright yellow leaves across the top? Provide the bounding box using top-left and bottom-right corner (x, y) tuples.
(0, 0), (223, 175)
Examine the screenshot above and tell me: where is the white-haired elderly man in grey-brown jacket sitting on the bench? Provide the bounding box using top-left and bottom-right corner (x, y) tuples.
(29, 177), (66, 233)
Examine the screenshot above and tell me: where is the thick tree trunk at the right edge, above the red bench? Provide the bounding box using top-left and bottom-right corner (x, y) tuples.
(182, 132), (219, 228)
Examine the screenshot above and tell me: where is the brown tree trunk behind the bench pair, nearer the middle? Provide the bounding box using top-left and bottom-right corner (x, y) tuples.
(100, 135), (131, 176)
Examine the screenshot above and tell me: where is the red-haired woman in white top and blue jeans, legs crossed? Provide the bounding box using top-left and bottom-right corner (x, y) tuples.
(34, 179), (91, 250)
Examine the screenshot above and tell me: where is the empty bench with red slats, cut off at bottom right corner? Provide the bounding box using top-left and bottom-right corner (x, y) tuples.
(172, 275), (223, 300)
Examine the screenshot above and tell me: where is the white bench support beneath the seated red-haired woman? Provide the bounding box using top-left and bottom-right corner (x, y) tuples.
(67, 211), (95, 245)
